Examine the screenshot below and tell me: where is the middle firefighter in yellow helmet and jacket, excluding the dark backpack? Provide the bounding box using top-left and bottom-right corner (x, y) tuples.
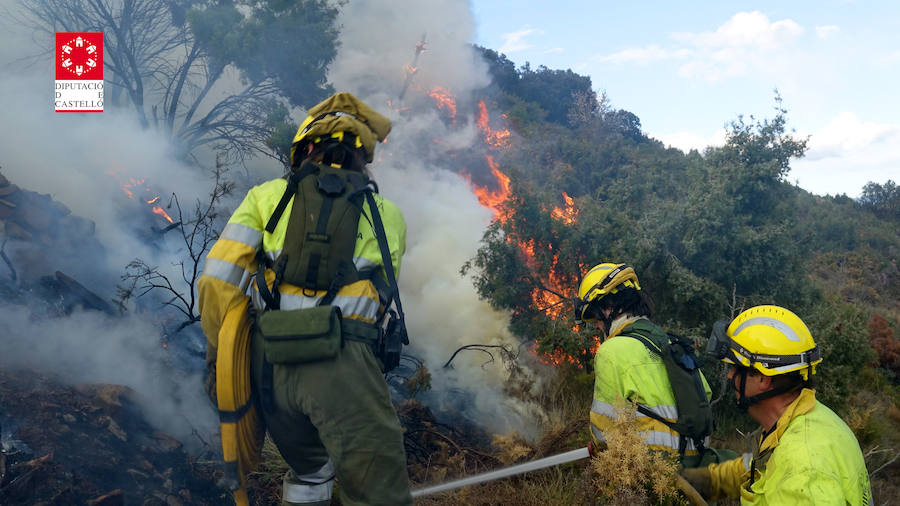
(575, 263), (715, 466)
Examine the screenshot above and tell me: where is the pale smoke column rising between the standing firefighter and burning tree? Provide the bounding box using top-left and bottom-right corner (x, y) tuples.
(329, 0), (535, 434)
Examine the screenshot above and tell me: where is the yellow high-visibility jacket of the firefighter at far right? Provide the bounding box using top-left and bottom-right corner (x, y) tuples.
(709, 389), (872, 506)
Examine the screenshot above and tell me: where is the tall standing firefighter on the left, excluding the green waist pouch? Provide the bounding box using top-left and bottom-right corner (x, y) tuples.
(199, 93), (412, 506)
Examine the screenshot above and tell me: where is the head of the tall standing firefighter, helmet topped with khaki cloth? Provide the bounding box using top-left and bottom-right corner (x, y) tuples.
(291, 92), (391, 170)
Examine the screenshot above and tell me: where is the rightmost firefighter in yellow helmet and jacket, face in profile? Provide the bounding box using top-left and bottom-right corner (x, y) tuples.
(682, 306), (872, 505)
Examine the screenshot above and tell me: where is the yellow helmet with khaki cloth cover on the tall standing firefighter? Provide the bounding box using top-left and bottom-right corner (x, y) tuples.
(291, 92), (391, 167)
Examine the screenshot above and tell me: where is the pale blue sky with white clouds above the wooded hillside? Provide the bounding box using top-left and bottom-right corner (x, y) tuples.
(471, 0), (900, 197)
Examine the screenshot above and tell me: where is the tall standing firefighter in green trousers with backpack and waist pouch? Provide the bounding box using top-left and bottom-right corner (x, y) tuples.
(198, 93), (412, 506)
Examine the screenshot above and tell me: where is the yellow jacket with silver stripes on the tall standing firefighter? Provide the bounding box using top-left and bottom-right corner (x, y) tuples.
(197, 179), (406, 346)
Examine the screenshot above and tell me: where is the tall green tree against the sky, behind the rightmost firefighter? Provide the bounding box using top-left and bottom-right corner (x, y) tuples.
(662, 96), (810, 308)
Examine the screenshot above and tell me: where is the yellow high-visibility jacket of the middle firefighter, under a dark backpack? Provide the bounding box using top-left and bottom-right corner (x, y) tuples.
(591, 317), (712, 455)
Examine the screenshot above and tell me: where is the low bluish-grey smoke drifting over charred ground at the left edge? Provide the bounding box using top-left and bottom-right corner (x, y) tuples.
(0, 306), (218, 445)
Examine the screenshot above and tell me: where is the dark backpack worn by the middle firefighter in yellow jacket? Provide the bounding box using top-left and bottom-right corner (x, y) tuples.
(621, 320), (713, 457)
